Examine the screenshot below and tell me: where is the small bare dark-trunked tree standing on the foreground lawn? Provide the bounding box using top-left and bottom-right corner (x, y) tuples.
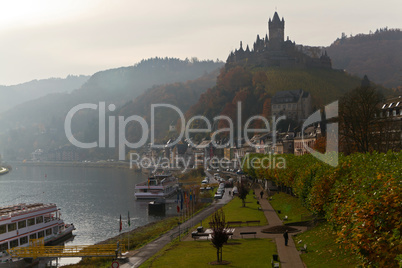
(210, 209), (229, 262)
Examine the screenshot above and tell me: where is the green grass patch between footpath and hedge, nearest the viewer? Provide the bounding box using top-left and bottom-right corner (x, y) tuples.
(294, 223), (359, 268)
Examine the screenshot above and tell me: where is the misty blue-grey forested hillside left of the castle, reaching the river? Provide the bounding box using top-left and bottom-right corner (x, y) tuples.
(0, 58), (223, 159)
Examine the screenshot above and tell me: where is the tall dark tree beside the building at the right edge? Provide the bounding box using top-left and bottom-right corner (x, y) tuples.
(339, 76), (383, 153)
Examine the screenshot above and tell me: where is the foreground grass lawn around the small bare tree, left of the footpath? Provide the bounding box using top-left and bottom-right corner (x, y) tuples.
(140, 238), (276, 268)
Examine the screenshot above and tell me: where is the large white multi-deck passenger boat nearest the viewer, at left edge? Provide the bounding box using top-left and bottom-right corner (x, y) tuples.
(0, 203), (75, 268)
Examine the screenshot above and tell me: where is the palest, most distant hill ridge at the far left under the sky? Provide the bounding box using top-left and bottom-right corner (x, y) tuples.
(0, 75), (89, 113)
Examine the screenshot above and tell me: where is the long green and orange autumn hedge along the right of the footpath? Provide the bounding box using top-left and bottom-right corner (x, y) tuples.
(244, 152), (402, 267)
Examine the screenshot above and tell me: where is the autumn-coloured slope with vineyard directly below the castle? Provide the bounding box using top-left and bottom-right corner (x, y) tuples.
(186, 66), (391, 142)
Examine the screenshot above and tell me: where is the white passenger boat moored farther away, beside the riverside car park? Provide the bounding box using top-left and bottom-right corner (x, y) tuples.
(134, 172), (179, 199)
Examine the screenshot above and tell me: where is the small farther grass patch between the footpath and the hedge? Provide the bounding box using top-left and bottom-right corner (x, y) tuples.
(269, 192), (311, 223)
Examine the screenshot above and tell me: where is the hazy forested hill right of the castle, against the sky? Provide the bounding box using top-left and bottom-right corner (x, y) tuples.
(326, 28), (402, 88)
